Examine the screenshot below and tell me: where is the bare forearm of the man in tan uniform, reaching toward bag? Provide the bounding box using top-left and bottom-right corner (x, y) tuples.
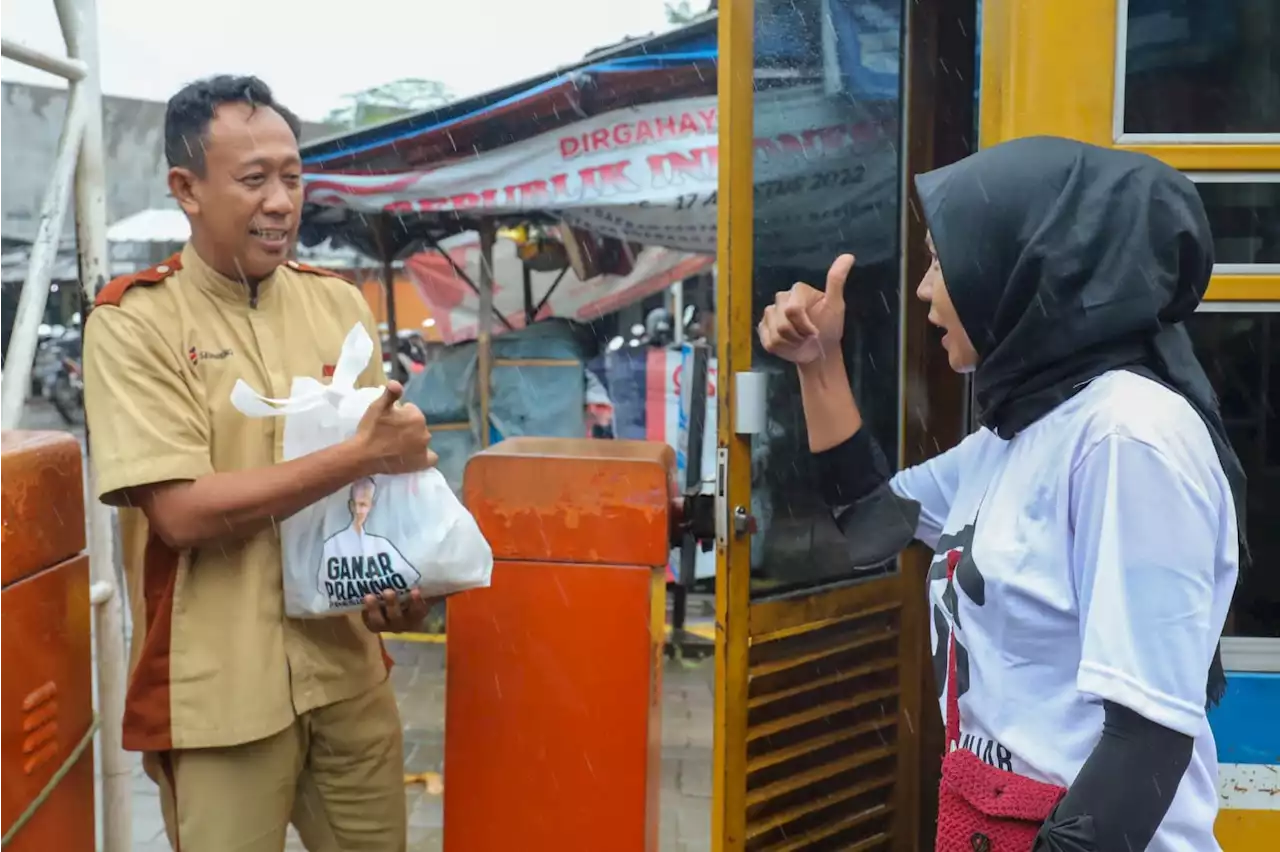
(129, 441), (370, 550)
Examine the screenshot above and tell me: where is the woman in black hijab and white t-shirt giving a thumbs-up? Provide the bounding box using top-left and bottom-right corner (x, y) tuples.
(759, 137), (1248, 852)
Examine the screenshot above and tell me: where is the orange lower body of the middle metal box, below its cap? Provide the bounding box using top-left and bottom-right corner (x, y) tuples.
(444, 562), (664, 852)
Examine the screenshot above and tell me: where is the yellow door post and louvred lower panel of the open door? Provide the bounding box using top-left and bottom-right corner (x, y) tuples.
(712, 0), (932, 852)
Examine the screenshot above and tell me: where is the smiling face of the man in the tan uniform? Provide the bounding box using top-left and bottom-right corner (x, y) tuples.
(169, 104), (302, 281)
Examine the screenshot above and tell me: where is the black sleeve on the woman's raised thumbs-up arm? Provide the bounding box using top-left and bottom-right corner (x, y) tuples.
(814, 429), (920, 569)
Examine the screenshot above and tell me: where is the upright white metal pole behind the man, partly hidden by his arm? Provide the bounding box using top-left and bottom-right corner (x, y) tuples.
(54, 0), (133, 852)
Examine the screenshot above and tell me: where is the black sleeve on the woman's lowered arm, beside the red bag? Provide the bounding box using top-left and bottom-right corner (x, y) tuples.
(1032, 701), (1196, 852)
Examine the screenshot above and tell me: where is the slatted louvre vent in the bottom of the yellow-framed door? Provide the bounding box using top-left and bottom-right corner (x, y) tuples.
(746, 604), (900, 852)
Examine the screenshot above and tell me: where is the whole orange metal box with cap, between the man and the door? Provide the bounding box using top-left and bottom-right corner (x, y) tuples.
(444, 438), (676, 852)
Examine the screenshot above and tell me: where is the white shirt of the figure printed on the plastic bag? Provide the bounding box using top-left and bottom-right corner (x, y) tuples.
(319, 525), (422, 609)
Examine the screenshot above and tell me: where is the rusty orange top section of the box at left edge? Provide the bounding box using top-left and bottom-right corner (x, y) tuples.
(0, 431), (84, 588)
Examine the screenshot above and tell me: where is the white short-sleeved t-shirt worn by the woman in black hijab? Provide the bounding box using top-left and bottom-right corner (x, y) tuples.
(892, 371), (1238, 852)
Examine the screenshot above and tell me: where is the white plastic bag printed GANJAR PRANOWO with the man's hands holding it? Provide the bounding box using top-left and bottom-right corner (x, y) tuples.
(232, 325), (493, 614)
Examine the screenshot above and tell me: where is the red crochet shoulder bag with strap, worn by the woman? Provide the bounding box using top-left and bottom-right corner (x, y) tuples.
(934, 550), (1066, 852)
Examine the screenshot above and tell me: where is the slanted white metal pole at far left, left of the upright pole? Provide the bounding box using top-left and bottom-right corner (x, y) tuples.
(0, 82), (88, 429)
